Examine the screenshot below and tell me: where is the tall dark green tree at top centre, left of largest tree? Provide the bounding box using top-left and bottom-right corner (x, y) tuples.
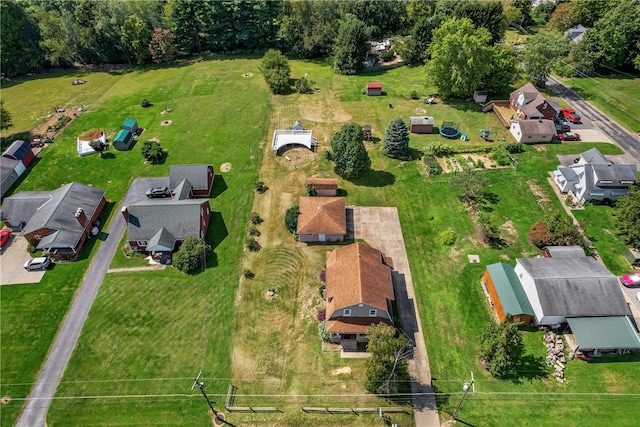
(332, 15), (369, 75)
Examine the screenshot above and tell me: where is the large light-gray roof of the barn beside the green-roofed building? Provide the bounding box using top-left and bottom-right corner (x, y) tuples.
(517, 257), (629, 317)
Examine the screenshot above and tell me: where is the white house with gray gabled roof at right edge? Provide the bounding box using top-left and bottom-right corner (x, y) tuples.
(553, 148), (638, 202)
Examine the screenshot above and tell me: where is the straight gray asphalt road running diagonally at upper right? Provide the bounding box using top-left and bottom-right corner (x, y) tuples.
(547, 77), (640, 165)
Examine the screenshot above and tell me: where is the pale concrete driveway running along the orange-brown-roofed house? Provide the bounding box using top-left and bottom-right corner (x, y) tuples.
(347, 206), (440, 427)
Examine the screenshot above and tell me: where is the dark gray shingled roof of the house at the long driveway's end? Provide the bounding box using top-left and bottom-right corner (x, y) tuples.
(127, 199), (207, 244)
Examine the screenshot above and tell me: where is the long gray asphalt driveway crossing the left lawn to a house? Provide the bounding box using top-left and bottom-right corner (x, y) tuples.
(16, 177), (169, 427)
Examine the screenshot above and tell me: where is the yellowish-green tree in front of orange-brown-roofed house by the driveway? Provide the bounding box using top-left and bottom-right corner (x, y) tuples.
(365, 323), (408, 394)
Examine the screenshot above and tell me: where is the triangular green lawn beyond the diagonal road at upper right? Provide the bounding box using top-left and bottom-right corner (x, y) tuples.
(560, 74), (640, 133)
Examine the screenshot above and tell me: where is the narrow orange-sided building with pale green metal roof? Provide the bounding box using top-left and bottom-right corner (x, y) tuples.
(482, 262), (534, 325)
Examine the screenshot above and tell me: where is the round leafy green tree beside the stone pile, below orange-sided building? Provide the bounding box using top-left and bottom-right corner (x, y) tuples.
(480, 319), (524, 378)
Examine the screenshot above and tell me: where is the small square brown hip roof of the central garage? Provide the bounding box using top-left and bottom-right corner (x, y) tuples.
(298, 197), (347, 234)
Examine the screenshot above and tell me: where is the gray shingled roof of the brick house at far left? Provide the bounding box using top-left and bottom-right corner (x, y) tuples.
(1, 182), (105, 248)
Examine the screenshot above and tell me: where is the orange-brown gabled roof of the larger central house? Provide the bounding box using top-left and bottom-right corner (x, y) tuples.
(324, 243), (394, 318)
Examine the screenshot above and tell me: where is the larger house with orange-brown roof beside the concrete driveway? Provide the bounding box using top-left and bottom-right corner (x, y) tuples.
(324, 243), (394, 348)
